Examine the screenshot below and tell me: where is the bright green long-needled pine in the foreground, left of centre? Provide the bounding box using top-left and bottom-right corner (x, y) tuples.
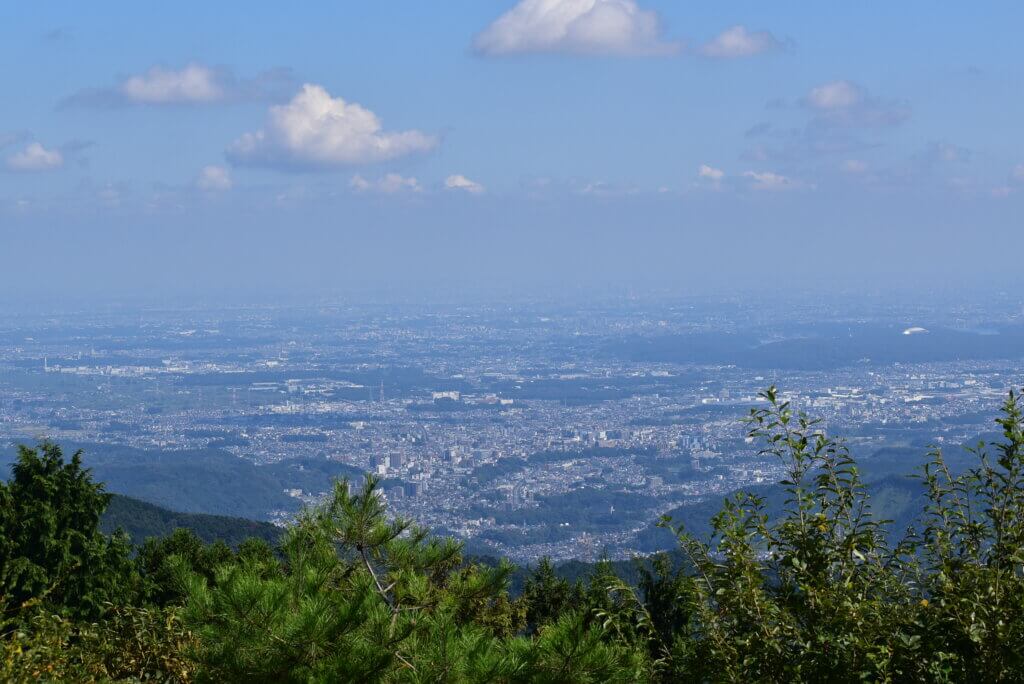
(178, 478), (642, 682)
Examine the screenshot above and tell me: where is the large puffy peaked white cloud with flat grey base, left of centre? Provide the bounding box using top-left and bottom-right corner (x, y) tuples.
(227, 84), (437, 169)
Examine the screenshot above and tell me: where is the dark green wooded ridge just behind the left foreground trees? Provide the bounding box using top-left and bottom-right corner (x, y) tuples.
(100, 495), (283, 547)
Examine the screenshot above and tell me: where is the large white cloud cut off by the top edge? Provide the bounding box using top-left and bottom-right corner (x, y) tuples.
(474, 0), (679, 55)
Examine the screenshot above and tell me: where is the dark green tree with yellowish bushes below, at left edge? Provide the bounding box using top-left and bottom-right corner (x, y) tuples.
(0, 442), (273, 682)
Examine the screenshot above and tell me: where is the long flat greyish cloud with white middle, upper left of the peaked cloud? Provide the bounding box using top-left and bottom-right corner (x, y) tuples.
(60, 62), (295, 108)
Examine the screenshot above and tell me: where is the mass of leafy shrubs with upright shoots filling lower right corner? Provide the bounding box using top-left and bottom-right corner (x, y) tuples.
(651, 388), (1024, 682)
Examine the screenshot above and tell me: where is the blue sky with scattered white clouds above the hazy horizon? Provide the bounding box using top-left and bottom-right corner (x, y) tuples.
(0, 0), (1024, 297)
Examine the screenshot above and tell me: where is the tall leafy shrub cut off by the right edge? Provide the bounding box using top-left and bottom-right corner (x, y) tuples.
(908, 392), (1024, 681)
